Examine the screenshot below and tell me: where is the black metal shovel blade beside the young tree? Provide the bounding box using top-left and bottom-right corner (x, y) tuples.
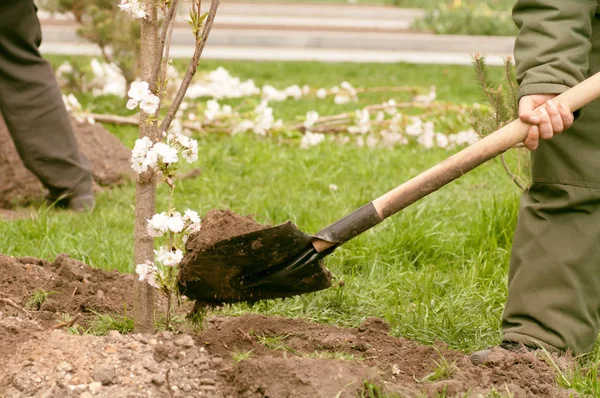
(179, 222), (333, 305)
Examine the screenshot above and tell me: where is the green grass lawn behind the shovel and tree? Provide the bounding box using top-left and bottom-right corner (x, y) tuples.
(0, 57), (597, 394)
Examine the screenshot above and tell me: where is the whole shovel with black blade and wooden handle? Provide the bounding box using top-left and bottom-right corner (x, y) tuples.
(179, 73), (600, 305)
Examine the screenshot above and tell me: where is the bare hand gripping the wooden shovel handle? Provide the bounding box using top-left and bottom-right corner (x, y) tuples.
(519, 94), (574, 151)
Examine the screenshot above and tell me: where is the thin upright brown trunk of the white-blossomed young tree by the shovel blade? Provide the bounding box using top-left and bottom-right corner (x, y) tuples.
(133, 0), (159, 333)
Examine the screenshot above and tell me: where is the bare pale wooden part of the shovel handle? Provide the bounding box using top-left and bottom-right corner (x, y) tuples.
(373, 73), (600, 219)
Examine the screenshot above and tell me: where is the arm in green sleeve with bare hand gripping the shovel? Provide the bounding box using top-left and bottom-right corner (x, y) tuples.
(513, 0), (597, 150)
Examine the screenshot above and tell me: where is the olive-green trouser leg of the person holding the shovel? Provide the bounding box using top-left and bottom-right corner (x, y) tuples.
(502, 21), (600, 354)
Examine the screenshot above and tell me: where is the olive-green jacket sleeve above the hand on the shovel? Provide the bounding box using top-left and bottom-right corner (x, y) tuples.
(513, 0), (597, 99)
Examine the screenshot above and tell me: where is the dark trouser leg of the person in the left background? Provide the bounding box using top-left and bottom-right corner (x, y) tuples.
(0, 0), (92, 197)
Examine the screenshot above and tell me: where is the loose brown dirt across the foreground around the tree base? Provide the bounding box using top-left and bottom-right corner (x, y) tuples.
(0, 255), (577, 398)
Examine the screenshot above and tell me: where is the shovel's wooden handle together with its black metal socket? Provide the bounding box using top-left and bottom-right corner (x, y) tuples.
(312, 73), (600, 252)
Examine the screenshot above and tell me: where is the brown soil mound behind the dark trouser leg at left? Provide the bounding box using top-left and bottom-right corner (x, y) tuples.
(0, 112), (133, 208)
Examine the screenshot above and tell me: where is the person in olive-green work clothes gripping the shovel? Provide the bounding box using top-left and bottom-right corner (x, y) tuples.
(471, 0), (600, 364)
